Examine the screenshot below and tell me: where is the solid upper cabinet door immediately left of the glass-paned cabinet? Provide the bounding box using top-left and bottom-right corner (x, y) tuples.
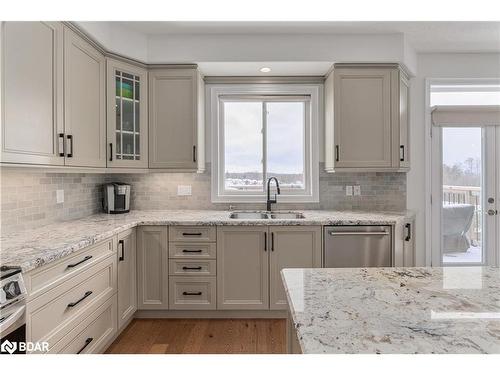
(64, 28), (106, 167)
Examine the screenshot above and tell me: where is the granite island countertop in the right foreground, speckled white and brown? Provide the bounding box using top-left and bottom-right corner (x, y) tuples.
(282, 267), (500, 354)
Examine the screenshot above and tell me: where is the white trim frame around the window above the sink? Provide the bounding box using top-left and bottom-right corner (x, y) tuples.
(207, 83), (323, 203)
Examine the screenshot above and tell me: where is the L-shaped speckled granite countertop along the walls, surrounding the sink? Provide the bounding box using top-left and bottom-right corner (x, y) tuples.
(0, 210), (411, 272)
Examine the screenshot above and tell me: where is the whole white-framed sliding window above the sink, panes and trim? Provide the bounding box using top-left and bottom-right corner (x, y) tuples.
(209, 84), (321, 203)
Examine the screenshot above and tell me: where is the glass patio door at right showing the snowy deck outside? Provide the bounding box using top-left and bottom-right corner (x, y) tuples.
(432, 126), (500, 266)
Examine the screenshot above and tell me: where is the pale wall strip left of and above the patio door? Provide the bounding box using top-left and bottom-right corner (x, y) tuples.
(407, 53), (500, 265)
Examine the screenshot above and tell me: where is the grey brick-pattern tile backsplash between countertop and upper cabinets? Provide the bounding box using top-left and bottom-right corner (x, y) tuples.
(0, 164), (406, 233)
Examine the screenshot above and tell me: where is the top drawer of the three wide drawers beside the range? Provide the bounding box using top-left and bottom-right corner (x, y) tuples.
(26, 239), (115, 299)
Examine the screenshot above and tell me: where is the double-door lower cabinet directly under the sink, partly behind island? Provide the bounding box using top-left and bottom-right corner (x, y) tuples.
(217, 226), (322, 310)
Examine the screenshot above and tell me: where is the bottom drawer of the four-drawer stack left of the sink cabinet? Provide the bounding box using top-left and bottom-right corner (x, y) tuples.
(168, 276), (216, 310)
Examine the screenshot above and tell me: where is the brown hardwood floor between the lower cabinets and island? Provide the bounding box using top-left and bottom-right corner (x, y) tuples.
(106, 319), (286, 354)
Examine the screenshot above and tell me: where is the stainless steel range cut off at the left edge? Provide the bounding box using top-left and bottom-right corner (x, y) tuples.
(0, 266), (27, 354)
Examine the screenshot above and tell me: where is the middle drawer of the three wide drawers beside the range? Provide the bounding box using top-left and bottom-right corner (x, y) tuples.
(26, 256), (116, 344)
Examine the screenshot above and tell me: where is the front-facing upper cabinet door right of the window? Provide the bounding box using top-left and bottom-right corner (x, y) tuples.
(334, 68), (392, 168)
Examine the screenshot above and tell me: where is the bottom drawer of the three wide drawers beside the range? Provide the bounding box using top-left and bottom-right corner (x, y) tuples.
(50, 295), (117, 354)
